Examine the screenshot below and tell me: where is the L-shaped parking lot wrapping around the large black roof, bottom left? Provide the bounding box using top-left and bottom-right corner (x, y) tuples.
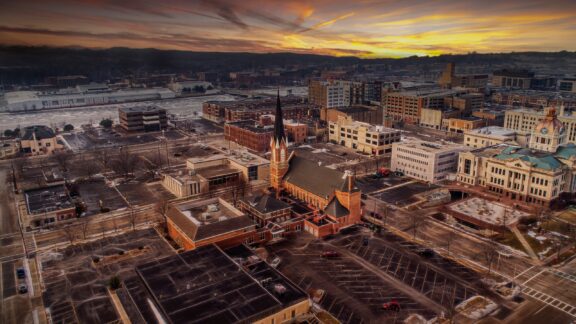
(39, 229), (174, 323)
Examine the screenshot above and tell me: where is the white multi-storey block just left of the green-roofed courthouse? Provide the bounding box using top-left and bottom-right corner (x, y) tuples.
(391, 140), (470, 183)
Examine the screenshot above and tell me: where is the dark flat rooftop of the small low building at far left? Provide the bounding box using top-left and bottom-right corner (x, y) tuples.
(24, 185), (74, 214)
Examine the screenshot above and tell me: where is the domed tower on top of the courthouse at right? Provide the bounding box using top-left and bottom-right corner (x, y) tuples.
(529, 108), (566, 152)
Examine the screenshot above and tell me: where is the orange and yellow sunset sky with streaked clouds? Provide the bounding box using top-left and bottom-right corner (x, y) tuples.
(0, 0), (576, 57)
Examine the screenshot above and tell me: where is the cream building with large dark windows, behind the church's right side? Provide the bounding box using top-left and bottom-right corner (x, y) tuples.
(328, 117), (401, 155)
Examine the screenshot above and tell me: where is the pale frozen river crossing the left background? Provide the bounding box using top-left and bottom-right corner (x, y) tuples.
(0, 87), (307, 132)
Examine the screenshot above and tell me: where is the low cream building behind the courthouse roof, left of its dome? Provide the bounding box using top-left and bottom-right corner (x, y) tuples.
(464, 126), (530, 148)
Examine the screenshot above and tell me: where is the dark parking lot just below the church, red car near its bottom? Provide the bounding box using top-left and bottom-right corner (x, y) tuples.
(272, 237), (438, 323)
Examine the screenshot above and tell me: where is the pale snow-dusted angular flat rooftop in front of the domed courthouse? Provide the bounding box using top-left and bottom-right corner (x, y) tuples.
(448, 197), (529, 226)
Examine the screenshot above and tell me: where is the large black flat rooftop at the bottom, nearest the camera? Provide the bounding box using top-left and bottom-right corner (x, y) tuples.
(126, 245), (308, 323)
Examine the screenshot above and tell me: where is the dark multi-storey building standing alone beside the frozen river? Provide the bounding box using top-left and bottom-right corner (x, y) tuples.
(118, 106), (168, 132)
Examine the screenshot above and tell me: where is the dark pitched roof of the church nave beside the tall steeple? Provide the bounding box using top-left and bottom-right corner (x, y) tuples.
(284, 155), (346, 197)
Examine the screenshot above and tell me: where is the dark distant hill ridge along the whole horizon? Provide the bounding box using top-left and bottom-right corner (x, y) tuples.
(0, 46), (576, 84)
